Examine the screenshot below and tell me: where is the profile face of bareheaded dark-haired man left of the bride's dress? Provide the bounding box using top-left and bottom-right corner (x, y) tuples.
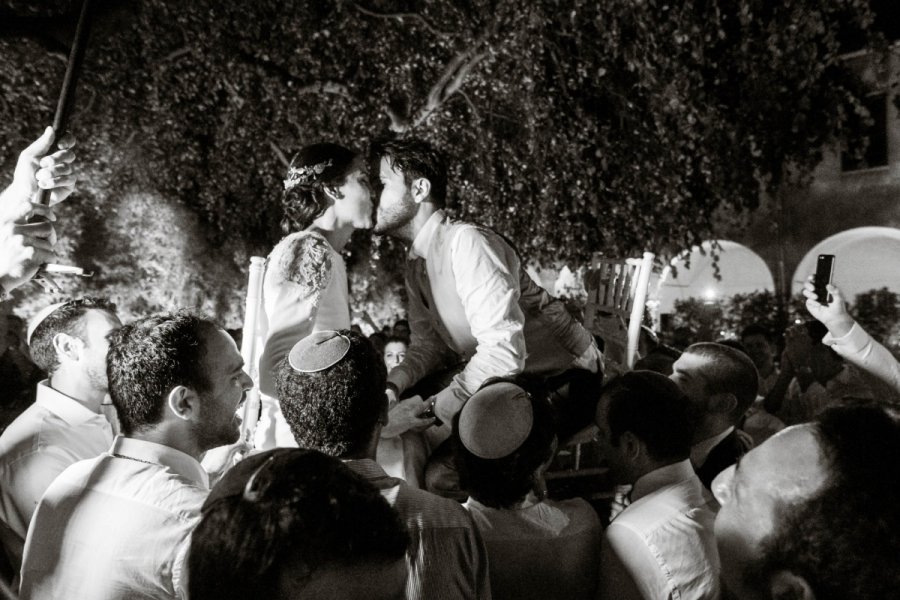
(195, 329), (253, 449)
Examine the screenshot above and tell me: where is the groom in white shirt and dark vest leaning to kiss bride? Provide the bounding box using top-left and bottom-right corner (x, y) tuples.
(373, 138), (602, 494)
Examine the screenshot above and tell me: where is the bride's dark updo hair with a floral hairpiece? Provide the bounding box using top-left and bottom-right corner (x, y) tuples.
(281, 143), (356, 235)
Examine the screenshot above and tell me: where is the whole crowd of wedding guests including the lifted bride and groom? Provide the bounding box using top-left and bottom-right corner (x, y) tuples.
(0, 129), (900, 600)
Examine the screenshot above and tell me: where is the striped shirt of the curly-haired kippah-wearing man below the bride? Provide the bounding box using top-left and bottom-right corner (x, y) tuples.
(345, 459), (491, 600)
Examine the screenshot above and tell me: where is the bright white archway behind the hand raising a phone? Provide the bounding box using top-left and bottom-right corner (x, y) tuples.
(791, 227), (900, 302)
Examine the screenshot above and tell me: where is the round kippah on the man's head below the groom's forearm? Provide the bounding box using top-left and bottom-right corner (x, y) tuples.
(459, 382), (534, 459)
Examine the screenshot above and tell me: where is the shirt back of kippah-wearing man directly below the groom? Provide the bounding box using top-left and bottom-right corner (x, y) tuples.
(464, 498), (603, 600)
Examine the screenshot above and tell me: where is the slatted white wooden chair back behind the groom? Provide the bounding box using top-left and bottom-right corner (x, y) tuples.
(584, 252), (655, 370)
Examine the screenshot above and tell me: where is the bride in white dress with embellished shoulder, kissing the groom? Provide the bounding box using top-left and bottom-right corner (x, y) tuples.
(256, 143), (373, 449)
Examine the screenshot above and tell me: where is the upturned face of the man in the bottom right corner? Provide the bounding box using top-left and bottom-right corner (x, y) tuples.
(712, 424), (827, 600)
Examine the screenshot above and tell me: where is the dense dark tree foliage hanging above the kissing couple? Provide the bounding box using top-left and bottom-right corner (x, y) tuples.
(0, 0), (875, 324)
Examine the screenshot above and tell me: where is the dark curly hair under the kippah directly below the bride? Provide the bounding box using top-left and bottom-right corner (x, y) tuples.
(275, 329), (387, 458)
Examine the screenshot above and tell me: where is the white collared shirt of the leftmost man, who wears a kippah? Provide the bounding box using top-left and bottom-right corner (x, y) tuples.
(0, 380), (113, 543)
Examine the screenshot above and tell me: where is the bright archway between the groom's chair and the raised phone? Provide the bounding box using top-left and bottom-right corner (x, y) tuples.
(651, 240), (775, 313)
